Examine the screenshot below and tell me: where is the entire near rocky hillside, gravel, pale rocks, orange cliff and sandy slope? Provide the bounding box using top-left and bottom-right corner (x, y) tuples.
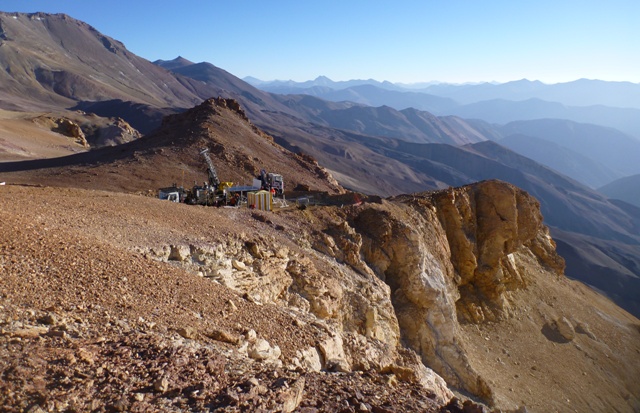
(0, 181), (640, 411)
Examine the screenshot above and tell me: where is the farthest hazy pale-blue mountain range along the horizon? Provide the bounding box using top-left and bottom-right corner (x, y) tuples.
(248, 77), (640, 139)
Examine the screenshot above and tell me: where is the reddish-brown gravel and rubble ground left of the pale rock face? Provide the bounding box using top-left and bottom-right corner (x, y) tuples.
(0, 186), (437, 413)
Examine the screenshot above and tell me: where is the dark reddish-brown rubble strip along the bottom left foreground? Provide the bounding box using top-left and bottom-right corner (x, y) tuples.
(0, 307), (444, 412)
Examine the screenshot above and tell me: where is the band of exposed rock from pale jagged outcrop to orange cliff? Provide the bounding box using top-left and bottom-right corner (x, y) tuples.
(144, 181), (571, 403)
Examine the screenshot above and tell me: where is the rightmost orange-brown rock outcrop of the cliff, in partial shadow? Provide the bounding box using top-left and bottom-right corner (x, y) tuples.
(424, 181), (564, 322)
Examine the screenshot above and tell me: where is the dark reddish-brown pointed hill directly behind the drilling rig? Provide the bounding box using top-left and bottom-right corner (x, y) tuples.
(0, 99), (342, 194)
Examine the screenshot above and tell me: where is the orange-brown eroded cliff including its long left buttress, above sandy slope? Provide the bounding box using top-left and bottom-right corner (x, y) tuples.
(348, 181), (564, 401)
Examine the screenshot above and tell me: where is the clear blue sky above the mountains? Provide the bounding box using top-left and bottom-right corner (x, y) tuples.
(0, 0), (640, 83)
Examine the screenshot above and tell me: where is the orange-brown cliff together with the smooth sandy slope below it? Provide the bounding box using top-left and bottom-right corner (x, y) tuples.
(330, 181), (640, 411)
